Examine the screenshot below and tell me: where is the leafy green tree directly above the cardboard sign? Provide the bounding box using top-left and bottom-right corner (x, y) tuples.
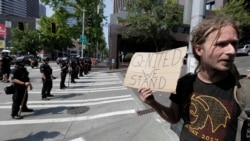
(118, 0), (183, 51)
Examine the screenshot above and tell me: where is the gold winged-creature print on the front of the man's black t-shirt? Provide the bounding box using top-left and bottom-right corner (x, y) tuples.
(185, 94), (233, 140)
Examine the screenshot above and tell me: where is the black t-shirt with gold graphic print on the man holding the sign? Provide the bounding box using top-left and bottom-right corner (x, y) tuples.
(170, 75), (241, 141)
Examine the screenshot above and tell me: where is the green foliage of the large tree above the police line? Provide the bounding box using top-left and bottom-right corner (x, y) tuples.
(41, 0), (106, 57)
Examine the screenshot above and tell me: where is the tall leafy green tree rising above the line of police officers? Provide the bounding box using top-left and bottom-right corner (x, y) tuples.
(41, 0), (105, 57)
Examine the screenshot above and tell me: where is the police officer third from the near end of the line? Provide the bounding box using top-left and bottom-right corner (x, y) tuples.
(60, 58), (69, 89)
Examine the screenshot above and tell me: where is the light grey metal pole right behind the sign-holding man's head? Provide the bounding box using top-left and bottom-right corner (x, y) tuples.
(184, 0), (206, 73)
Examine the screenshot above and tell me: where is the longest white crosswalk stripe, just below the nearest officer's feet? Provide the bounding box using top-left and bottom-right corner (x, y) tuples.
(0, 109), (136, 125)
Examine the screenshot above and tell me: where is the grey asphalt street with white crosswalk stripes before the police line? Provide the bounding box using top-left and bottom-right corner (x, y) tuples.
(0, 62), (148, 141)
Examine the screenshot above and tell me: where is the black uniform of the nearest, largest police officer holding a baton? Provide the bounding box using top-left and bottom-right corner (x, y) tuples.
(11, 67), (30, 117)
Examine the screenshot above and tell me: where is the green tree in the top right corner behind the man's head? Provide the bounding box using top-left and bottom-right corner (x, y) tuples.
(216, 0), (250, 43)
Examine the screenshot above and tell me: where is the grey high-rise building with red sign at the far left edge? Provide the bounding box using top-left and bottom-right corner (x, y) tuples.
(0, 0), (43, 50)
